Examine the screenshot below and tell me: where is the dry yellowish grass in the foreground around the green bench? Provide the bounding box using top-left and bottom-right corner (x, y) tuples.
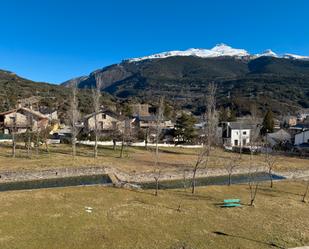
(0, 181), (309, 249)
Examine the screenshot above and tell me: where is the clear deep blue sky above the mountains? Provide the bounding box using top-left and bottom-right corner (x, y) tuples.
(0, 0), (309, 83)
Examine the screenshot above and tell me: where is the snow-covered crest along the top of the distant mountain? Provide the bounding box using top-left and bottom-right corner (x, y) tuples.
(128, 43), (309, 62)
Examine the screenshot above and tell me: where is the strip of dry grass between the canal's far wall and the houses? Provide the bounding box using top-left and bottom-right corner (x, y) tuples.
(0, 145), (309, 173)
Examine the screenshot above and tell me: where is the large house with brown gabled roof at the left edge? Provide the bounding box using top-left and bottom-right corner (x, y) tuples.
(0, 107), (49, 134)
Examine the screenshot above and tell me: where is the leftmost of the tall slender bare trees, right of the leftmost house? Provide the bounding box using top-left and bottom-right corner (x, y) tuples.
(69, 84), (80, 158)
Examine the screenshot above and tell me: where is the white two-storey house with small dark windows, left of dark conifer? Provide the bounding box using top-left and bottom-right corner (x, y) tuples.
(221, 122), (257, 147)
